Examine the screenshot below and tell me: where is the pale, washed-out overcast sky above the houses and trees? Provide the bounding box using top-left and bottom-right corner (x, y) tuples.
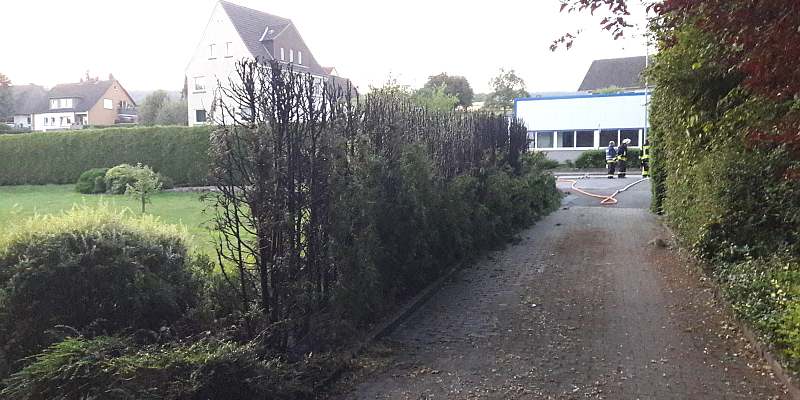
(0, 0), (647, 93)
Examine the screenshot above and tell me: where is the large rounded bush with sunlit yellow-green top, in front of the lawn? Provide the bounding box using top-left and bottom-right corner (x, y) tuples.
(0, 204), (201, 376)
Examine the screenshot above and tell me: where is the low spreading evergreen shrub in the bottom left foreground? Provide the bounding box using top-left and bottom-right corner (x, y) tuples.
(0, 335), (338, 400)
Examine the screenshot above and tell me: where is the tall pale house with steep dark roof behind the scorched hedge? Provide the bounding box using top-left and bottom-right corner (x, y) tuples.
(186, 1), (350, 126)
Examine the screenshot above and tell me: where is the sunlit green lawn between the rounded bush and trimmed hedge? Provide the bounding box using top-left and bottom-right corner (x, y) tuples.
(0, 185), (214, 254)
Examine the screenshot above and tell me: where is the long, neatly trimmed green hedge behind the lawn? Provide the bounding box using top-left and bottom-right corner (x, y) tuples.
(0, 126), (212, 186)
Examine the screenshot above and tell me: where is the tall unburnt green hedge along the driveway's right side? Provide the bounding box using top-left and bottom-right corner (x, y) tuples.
(649, 11), (800, 370)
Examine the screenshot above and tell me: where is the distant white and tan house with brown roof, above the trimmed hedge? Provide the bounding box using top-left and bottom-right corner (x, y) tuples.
(31, 79), (136, 131)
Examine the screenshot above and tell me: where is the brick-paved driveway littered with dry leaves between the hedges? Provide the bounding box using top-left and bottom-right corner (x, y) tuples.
(326, 182), (790, 399)
